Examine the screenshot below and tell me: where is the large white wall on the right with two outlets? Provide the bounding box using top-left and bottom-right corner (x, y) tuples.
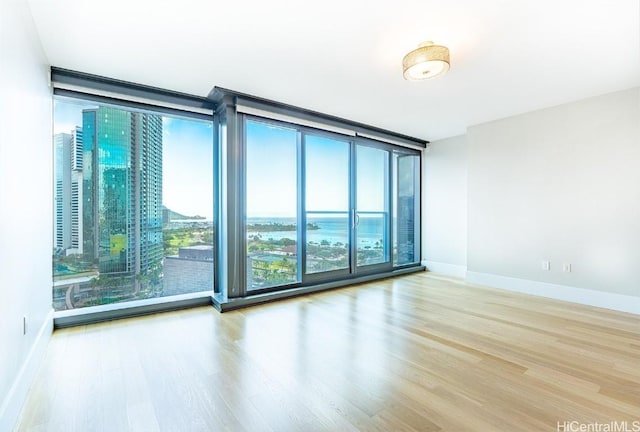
(464, 88), (640, 298)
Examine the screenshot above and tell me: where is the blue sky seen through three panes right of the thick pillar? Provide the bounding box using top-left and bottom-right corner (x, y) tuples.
(246, 121), (388, 217)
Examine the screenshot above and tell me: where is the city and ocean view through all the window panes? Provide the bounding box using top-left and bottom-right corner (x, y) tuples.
(52, 98), (419, 310)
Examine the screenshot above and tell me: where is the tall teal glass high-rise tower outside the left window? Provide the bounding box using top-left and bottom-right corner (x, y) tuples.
(80, 107), (162, 275)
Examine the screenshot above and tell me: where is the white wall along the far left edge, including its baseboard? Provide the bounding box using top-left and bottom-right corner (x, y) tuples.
(0, 0), (53, 431)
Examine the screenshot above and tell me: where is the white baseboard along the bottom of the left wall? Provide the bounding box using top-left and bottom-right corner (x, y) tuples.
(0, 309), (53, 431)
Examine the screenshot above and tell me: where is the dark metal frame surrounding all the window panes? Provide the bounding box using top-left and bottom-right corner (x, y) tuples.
(51, 67), (429, 320)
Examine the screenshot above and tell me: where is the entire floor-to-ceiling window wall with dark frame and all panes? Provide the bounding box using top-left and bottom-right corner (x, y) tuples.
(52, 73), (425, 318)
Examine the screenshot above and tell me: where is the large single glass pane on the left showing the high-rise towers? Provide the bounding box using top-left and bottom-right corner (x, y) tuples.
(53, 98), (213, 310)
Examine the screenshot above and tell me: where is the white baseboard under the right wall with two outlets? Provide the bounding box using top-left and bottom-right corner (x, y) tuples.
(466, 271), (640, 315)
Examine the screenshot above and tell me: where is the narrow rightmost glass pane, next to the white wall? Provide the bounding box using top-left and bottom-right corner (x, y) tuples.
(393, 153), (420, 266)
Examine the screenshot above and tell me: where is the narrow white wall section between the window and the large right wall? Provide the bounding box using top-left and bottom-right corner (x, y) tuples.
(422, 135), (467, 277)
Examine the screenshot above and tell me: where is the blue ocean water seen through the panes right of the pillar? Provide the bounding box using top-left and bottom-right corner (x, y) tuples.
(247, 215), (385, 247)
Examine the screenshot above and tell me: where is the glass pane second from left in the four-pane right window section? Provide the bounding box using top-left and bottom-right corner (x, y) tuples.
(305, 135), (349, 274)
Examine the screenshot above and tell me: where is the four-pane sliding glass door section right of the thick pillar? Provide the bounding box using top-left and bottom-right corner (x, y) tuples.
(243, 116), (420, 292)
